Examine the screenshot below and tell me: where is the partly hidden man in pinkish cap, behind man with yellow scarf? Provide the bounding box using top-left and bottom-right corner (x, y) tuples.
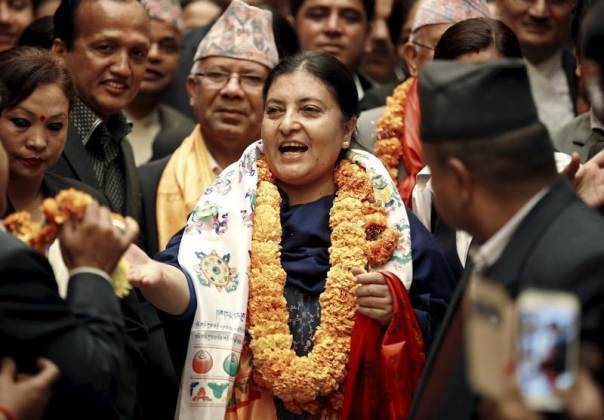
(124, 0), (195, 166)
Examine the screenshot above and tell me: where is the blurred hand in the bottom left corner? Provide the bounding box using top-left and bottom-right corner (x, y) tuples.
(0, 358), (59, 420)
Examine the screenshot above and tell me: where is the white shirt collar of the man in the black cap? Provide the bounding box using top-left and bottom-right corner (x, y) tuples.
(470, 186), (549, 273)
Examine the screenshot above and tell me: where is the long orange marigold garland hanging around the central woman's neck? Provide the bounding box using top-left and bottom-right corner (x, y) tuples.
(248, 158), (398, 415)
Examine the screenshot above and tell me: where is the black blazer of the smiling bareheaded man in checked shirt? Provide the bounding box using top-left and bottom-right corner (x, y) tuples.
(49, 123), (141, 225)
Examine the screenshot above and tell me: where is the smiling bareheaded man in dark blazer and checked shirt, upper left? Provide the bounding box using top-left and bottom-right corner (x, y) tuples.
(51, 0), (151, 220)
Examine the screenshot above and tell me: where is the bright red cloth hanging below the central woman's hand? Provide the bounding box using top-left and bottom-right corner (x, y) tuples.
(341, 272), (426, 420)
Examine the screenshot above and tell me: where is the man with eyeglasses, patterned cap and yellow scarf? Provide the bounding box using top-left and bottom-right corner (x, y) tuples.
(140, 0), (279, 255)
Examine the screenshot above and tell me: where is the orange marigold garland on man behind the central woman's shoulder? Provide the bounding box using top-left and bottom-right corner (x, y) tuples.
(374, 77), (415, 181)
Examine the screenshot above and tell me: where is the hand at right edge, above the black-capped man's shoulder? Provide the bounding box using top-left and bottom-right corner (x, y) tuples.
(563, 151), (604, 208)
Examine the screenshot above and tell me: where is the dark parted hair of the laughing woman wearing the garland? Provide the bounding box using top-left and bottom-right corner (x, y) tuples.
(262, 51), (359, 121)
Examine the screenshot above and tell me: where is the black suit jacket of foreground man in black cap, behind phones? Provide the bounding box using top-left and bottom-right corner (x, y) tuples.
(410, 178), (604, 419)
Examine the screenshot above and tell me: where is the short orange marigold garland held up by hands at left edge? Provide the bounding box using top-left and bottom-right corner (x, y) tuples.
(3, 188), (132, 298)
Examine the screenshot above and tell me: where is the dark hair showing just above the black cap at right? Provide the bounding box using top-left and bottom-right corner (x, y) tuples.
(434, 18), (522, 60)
